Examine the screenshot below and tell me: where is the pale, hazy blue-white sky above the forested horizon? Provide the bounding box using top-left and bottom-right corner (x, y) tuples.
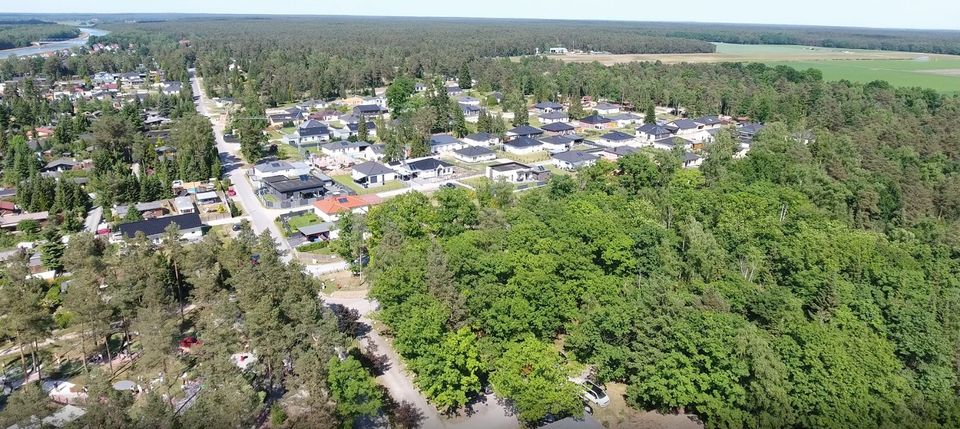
(0, 0), (960, 30)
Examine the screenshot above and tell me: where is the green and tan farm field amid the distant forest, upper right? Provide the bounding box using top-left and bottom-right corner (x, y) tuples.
(552, 43), (960, 92)
